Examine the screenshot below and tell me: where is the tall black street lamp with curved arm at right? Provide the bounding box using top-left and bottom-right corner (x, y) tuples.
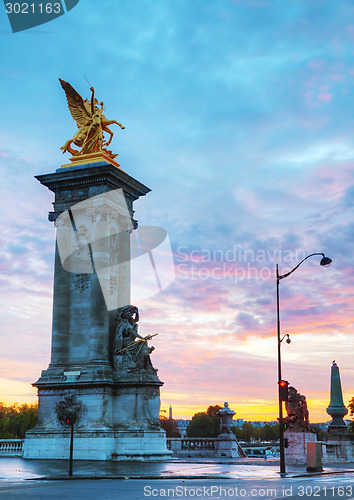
(276, 253), (332, 474)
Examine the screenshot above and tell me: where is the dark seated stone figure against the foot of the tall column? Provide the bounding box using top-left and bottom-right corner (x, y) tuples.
(113, 306), (157, 373)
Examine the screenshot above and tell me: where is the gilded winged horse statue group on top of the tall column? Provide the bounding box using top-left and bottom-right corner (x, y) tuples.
(59, 78), (125, 158)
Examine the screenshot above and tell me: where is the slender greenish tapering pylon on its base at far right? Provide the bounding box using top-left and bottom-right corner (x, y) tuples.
(326, 361), (348, 440)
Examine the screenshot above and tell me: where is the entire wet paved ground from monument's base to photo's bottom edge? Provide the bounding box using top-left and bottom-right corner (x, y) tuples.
(0, 457), (354, 500)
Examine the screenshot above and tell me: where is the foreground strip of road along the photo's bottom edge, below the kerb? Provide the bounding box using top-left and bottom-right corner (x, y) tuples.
(0, 474), (354, 500)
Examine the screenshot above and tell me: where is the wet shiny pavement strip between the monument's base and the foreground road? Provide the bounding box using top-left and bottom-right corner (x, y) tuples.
(0, 457), (354, 481)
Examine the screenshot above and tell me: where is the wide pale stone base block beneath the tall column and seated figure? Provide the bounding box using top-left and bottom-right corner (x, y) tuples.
(23, 377), (171, 461)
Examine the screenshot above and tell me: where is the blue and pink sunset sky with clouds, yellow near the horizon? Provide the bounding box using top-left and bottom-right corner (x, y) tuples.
(0, 0), (354, 422)
